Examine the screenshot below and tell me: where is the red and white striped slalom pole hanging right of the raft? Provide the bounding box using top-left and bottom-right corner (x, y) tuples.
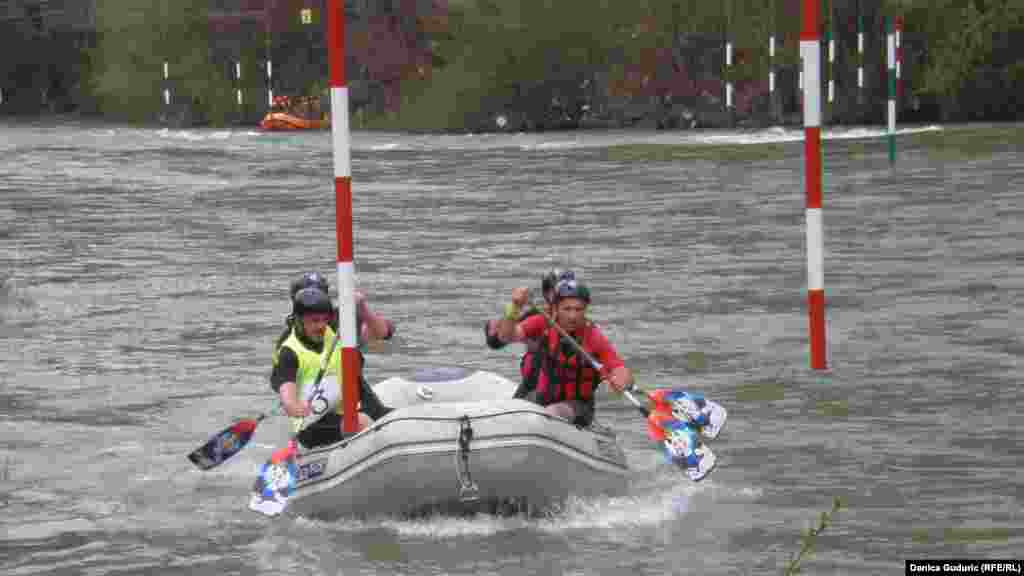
(800, 0), (826, 370)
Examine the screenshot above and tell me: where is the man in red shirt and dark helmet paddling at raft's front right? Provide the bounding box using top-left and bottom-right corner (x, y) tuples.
(498, 278), (633, 426)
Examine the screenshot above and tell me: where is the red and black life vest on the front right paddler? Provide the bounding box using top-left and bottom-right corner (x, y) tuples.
(536, 324), (601, 405)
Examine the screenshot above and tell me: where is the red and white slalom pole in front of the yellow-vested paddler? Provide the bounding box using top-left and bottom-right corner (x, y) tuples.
(327, 0), (359, 433)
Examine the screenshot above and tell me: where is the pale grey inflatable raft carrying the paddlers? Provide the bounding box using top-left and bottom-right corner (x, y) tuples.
(252, 368), (629, 520)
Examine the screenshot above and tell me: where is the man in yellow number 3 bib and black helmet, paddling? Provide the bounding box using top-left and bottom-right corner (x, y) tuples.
(270, 286), (382, 448)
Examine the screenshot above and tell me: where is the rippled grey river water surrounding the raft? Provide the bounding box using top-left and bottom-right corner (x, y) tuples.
(0, 121), (1024, 576)
